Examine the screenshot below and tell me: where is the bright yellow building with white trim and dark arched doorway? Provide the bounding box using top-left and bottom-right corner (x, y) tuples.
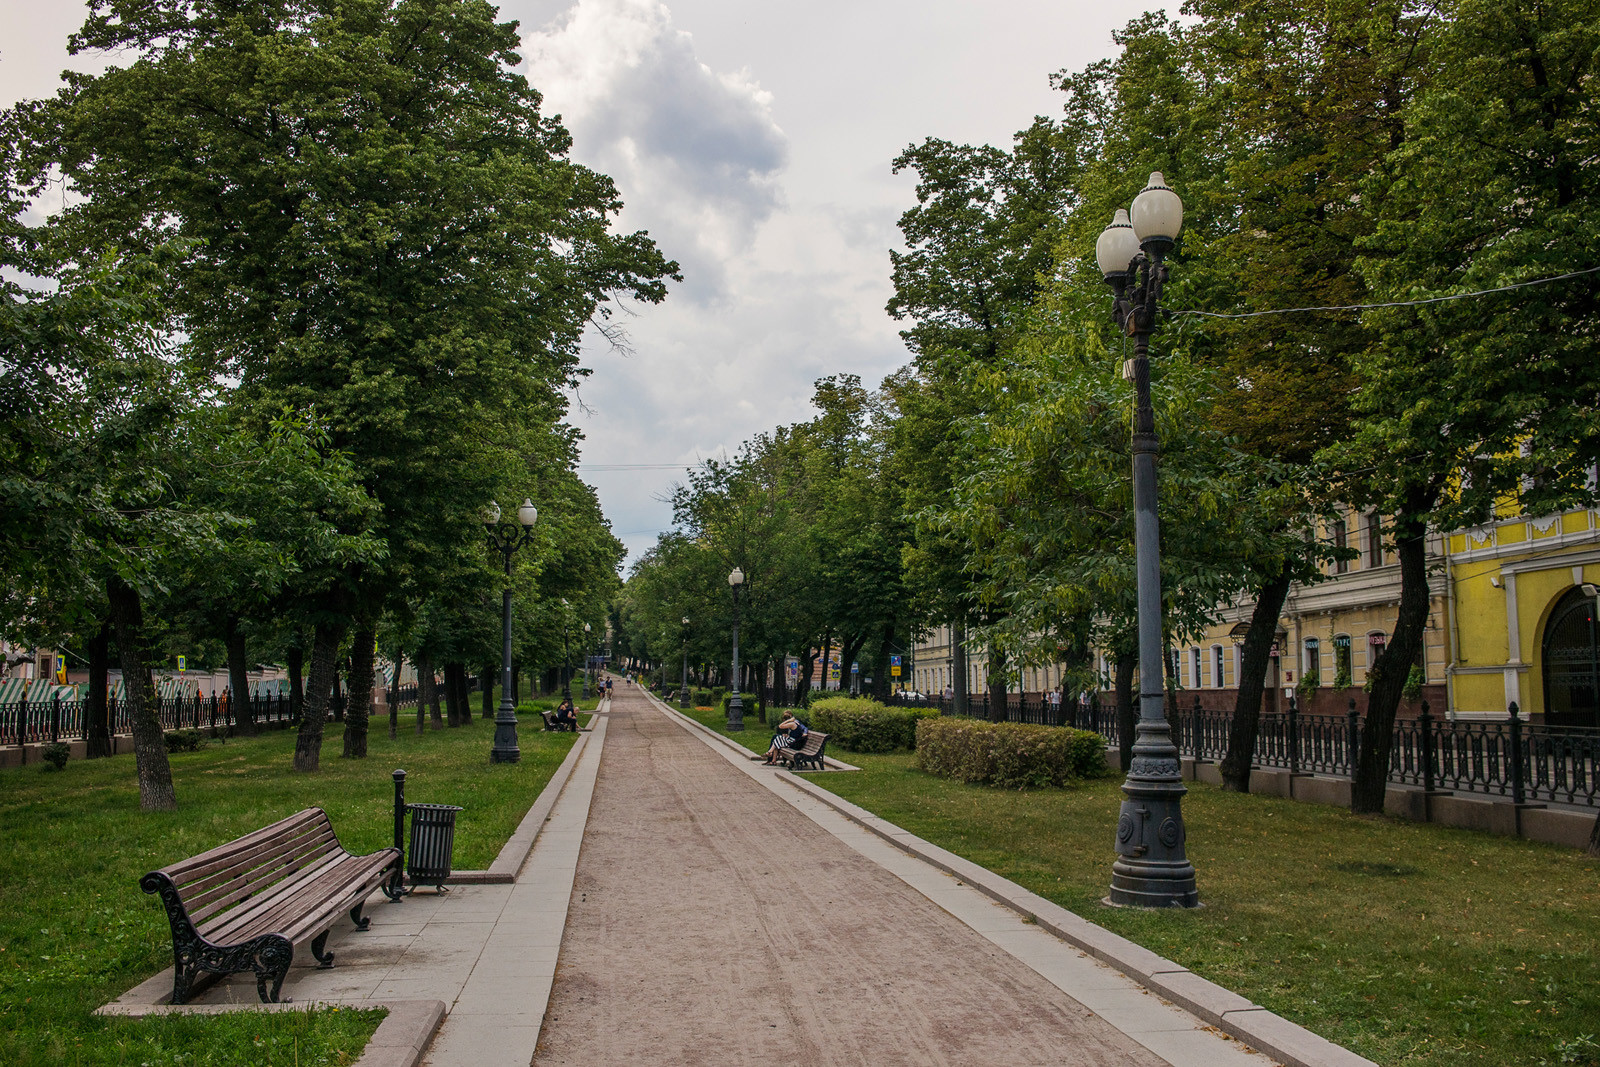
(1446, 510), (1600, 726)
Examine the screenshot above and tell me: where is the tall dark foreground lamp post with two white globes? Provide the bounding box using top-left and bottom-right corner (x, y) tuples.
(1094, 173), (1200, 907)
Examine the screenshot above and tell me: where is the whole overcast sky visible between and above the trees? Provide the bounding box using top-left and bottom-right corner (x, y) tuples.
(0, 0), (1154, 561)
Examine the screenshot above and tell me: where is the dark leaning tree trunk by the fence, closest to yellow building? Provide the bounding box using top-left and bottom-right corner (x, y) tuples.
(1350, 499), (1429, 814)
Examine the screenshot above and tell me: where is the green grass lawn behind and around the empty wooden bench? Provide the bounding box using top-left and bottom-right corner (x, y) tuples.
(0, 713), (573, 1067)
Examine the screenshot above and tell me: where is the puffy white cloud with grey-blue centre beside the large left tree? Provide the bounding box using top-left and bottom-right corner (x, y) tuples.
(523, 0), (789, 304)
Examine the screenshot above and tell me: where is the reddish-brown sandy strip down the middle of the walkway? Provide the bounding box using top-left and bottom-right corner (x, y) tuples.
(533, 689), (1163, 1067)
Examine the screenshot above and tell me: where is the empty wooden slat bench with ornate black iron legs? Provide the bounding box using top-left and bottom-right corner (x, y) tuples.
(139, 808), (400, 1005)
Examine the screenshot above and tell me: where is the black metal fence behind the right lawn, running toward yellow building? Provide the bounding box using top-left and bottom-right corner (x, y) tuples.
(901, 693), (1600, 808)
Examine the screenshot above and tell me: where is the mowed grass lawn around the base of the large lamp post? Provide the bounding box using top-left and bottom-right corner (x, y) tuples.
(800, 751), (1600, 1067)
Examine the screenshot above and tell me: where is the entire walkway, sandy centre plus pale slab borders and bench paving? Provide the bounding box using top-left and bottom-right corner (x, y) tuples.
(190, 686), (1272, 1067)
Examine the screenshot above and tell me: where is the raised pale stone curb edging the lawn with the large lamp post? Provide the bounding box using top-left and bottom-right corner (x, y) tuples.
(774, 777), (1378, 1067)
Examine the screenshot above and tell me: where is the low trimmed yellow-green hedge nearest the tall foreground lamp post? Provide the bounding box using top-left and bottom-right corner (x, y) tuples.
(917, 717), (1109, 789)
